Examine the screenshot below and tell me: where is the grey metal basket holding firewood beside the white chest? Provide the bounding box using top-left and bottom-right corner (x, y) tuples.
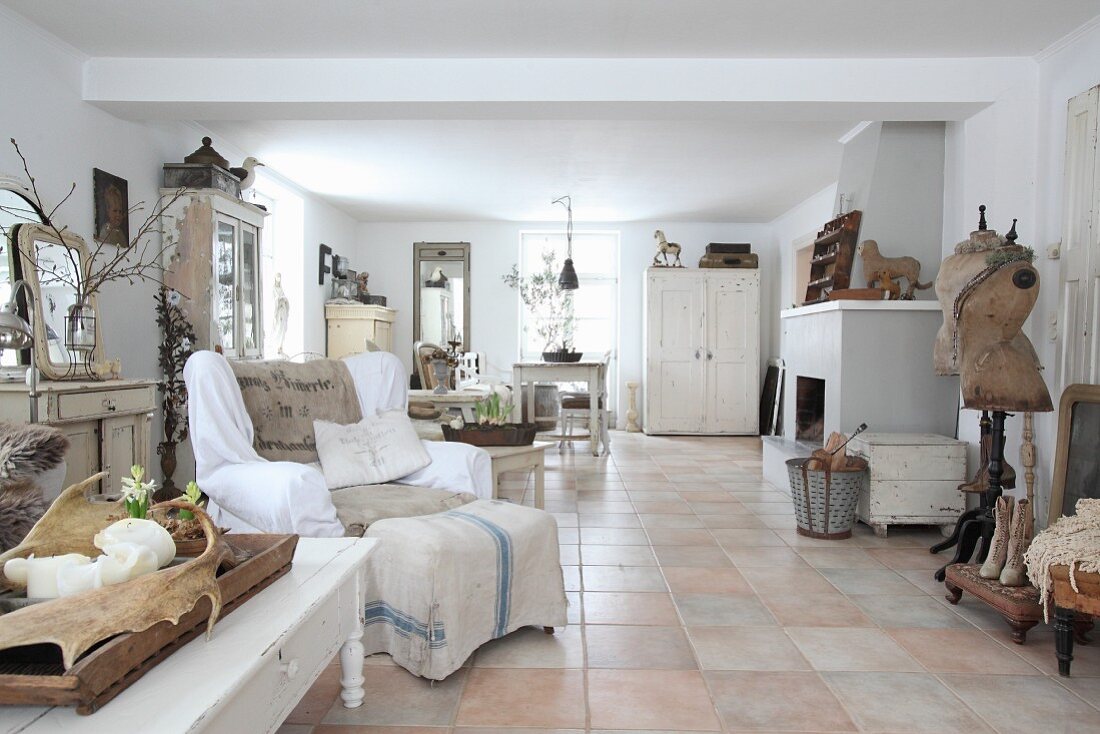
(787, 459), (870, 540)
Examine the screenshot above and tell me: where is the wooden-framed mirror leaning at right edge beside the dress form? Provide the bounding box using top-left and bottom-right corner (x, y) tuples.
(1047, 385), (1100, 525)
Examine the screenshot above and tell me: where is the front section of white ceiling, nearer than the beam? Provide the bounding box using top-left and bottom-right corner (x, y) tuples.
(2, 0), (1100, 58)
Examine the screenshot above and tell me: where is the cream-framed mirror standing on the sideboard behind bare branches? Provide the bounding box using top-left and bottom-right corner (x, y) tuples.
(15, 224), (103, 380)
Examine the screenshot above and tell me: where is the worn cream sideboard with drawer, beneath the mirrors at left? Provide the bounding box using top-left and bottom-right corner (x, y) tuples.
(0, 380), (156, 500)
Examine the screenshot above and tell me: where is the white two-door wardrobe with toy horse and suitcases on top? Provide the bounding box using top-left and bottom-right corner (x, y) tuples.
(641, 267), (760, 435)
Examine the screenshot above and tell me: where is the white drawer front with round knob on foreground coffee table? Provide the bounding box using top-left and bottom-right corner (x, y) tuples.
(202, 593), (342, 733)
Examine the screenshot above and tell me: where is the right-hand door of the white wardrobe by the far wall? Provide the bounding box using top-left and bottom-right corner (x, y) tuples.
(705, 272), (760, 434)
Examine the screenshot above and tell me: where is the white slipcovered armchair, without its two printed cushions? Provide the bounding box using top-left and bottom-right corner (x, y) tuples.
(184, 351), (493, 537)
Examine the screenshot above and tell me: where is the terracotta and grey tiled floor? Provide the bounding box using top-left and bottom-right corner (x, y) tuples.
(282, 432), (1100, 734)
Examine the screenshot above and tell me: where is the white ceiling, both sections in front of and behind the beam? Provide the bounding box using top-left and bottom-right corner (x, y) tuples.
(0, 0), (1100, 222)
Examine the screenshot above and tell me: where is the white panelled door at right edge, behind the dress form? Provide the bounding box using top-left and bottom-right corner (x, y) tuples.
(1058, 87), (1100, 392)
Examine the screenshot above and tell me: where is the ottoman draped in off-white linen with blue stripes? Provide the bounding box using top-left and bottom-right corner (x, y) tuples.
(363, 500), (568, 680)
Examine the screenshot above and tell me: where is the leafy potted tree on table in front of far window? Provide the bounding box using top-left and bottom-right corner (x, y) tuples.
(503, 251), (581, 362)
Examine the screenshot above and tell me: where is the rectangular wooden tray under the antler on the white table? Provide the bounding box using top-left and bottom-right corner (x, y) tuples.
(0, 535), (298, 714)
